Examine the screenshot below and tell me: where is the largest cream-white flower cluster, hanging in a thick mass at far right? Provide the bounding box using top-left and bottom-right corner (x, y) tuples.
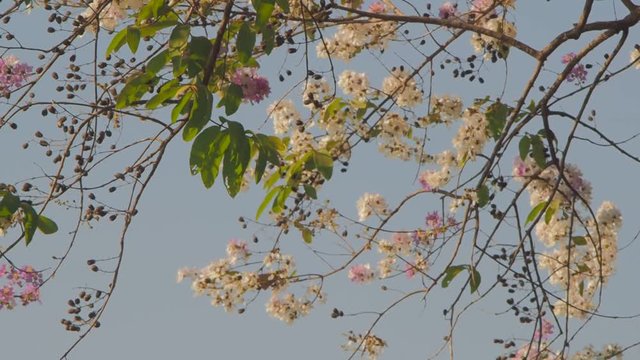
(514, 158), (622, 318)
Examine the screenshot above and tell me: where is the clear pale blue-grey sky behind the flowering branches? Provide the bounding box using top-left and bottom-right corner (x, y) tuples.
(0, 0), (640, 360)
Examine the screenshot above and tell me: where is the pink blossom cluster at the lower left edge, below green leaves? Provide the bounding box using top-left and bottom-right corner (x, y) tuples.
(0, 264), (42, 310)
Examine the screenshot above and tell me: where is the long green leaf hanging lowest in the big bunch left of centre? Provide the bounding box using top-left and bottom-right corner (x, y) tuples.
(222, 121), (251, 197)
